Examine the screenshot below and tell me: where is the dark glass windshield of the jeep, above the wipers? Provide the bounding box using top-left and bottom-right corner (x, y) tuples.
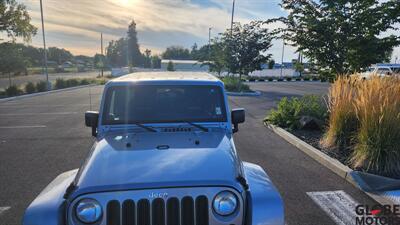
(102, 85), (226, 125)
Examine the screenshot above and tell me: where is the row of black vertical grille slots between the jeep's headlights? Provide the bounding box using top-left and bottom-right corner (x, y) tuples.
(106, 196), (209, 225)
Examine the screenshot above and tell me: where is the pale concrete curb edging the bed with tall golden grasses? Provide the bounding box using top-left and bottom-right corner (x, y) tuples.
(264, 123), (398, 205)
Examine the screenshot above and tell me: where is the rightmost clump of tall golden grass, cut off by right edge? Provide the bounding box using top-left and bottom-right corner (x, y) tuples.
(351, 76), (400, 178)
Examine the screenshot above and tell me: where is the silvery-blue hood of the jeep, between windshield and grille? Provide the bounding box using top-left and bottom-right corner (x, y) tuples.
(75, 132), (241, 194)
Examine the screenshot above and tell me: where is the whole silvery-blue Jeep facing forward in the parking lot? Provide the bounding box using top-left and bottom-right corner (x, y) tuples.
(23, 72), (284, 225)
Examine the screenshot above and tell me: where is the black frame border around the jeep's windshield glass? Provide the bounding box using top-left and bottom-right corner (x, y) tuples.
(101, 84), (228, 125)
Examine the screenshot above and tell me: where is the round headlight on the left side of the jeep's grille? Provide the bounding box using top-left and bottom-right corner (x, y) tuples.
(75, 198), (103, 223)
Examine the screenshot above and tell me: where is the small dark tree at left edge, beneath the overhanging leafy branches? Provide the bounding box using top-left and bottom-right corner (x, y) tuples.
(0, 42), (26, 86)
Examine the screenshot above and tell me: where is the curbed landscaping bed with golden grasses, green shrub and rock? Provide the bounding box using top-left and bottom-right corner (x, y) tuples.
(265, 77), (400, 179)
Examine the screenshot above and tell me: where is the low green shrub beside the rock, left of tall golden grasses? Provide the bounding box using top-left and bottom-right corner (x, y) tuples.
(265, 95), (327, 129)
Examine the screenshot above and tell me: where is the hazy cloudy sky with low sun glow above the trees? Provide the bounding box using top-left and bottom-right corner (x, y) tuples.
(8, 0), (400, 62)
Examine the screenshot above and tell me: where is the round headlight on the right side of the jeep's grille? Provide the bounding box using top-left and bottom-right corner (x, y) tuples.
(213, 191), (238, 216)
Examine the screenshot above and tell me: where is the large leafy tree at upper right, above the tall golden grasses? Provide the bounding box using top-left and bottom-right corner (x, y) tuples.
(267, 0), (400, 74)
